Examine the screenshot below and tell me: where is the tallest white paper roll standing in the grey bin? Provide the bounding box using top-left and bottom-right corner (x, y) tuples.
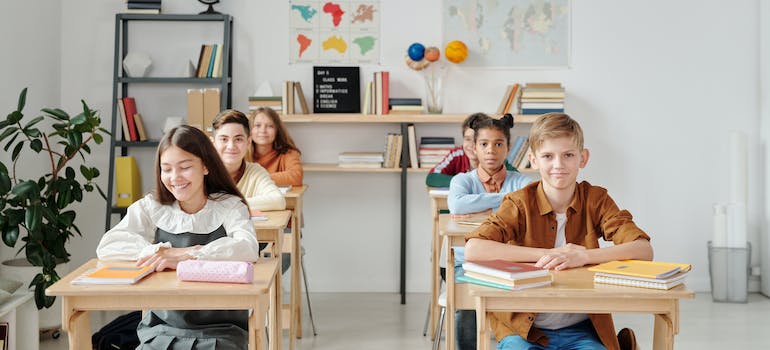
(727, 130), (749, 205)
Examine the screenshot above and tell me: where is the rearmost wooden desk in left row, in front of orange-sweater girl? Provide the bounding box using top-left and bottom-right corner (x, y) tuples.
(282, 185), (308, 350)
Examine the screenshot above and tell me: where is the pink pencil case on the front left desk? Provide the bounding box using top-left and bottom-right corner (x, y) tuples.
(176, 260), (254, 283)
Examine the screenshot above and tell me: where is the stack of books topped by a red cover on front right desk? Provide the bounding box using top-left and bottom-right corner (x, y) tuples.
(457, 260), (553, 290)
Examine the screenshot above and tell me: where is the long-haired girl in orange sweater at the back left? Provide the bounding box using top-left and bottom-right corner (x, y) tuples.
(248, 107), (303, 186)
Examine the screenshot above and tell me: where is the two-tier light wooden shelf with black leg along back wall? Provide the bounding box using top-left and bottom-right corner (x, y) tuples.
(281, 113), (539, 304)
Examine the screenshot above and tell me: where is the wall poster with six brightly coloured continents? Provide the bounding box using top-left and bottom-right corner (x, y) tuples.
(289, 1), (380, 64)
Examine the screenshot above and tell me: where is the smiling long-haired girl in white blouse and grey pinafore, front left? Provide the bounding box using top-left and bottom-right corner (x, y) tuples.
(96, 125), (259, 349)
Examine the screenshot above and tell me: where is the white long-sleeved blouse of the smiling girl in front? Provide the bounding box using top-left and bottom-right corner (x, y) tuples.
(96, 194), (259, 261)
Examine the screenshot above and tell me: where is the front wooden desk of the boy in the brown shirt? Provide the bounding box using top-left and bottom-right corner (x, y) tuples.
(468, 267), (695, 350)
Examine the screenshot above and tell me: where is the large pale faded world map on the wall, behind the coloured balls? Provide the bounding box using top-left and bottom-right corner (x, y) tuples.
(443, 0), (570, 67)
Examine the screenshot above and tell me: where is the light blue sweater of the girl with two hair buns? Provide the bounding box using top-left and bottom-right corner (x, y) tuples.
(447, 169), (532, 214)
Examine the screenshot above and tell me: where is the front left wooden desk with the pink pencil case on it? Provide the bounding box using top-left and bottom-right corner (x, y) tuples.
(46, 258), (281, 350)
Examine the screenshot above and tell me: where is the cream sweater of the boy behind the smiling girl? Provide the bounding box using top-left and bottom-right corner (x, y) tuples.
(237, 162), (286, 211)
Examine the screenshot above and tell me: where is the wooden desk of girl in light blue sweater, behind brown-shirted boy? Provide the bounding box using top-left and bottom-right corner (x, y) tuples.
(438, 214), (480, 350)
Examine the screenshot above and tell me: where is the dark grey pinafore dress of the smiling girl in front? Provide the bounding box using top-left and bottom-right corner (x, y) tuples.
(137, 226), (249, 350)
